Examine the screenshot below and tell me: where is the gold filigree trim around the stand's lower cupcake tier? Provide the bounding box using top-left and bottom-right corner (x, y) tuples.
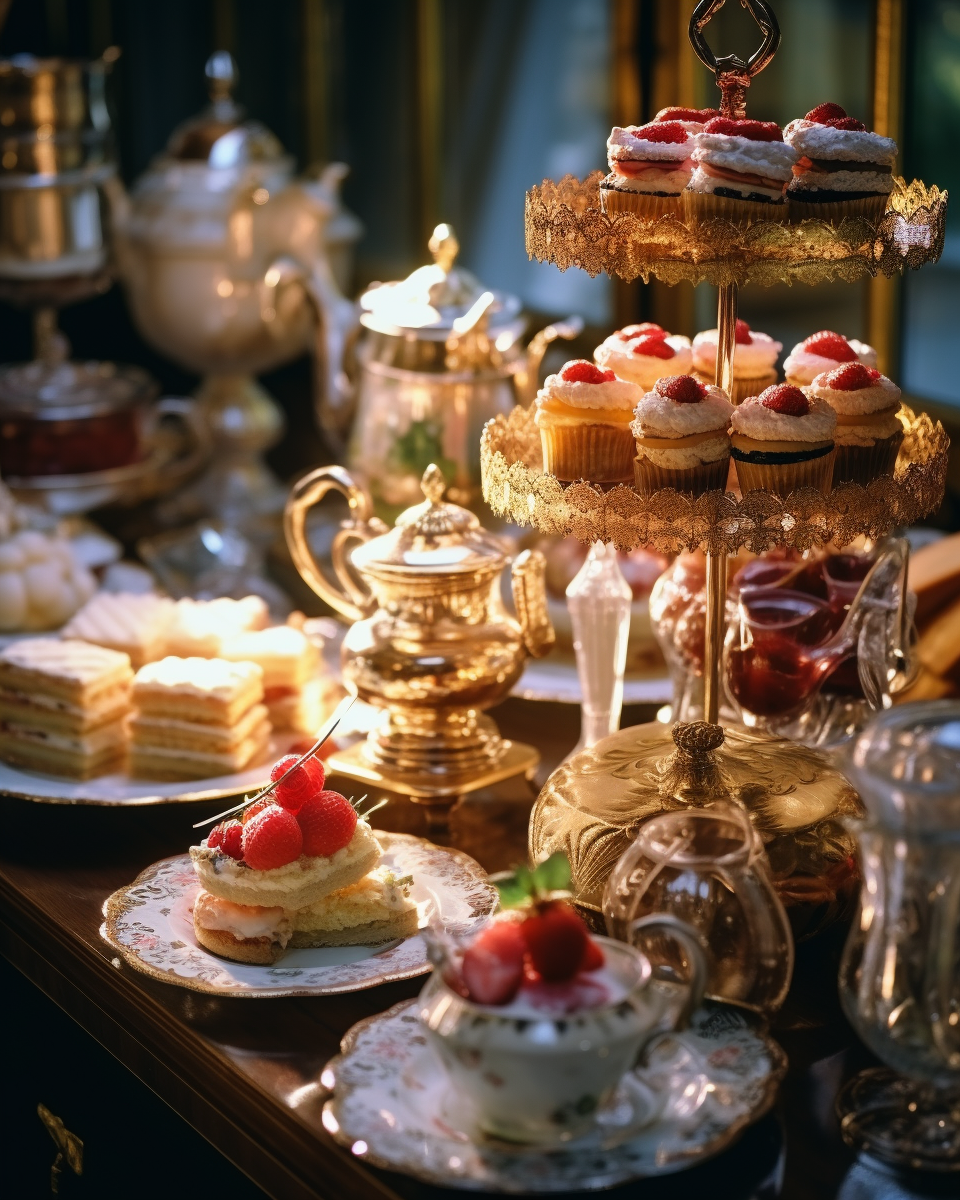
(480, 406), (950, 554)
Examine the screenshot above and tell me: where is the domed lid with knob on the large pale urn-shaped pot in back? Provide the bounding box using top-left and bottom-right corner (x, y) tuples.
(164, 50), (287, 169)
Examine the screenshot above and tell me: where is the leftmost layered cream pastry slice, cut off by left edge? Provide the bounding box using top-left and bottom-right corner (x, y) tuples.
(0, 638), (133, 779)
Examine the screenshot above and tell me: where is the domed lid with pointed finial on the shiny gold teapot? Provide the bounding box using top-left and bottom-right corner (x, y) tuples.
(352, 463), (508, 575)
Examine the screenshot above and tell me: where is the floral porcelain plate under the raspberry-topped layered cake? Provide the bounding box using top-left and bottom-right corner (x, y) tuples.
(100, 832), (498, 997)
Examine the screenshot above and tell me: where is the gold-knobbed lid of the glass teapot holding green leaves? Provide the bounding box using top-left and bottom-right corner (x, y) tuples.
(360, 224), (521, 342)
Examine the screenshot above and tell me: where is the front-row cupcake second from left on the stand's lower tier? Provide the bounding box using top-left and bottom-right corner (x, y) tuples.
(631, 376), (733, 496)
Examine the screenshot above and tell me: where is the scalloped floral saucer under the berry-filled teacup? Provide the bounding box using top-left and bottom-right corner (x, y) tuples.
(320, 1000), (786, 1193)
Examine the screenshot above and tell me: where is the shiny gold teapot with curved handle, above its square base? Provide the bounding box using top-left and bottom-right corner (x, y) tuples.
(284, 464), (553, 777)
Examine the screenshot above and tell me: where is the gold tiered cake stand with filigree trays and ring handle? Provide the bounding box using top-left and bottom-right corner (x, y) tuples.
(481, 0), (949, 931)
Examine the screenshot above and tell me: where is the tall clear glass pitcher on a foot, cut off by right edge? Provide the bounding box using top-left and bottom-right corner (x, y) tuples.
(838, 701), (960, 1171)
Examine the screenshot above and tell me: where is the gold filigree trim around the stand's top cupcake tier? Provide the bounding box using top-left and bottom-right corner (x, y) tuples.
(524, 170), (947, 286)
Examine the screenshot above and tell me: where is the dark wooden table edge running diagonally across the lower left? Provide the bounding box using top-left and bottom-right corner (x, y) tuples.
(0, 875), (397, 1200)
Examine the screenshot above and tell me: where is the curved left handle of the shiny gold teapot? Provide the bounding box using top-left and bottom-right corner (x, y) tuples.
(283, 467), (386, 620)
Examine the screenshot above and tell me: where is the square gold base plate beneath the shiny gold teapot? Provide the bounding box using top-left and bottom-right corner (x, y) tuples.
(325, 738), (540, 836)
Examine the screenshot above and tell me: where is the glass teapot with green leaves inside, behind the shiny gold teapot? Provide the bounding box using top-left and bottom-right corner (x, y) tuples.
(347, 224), (583, 520)
